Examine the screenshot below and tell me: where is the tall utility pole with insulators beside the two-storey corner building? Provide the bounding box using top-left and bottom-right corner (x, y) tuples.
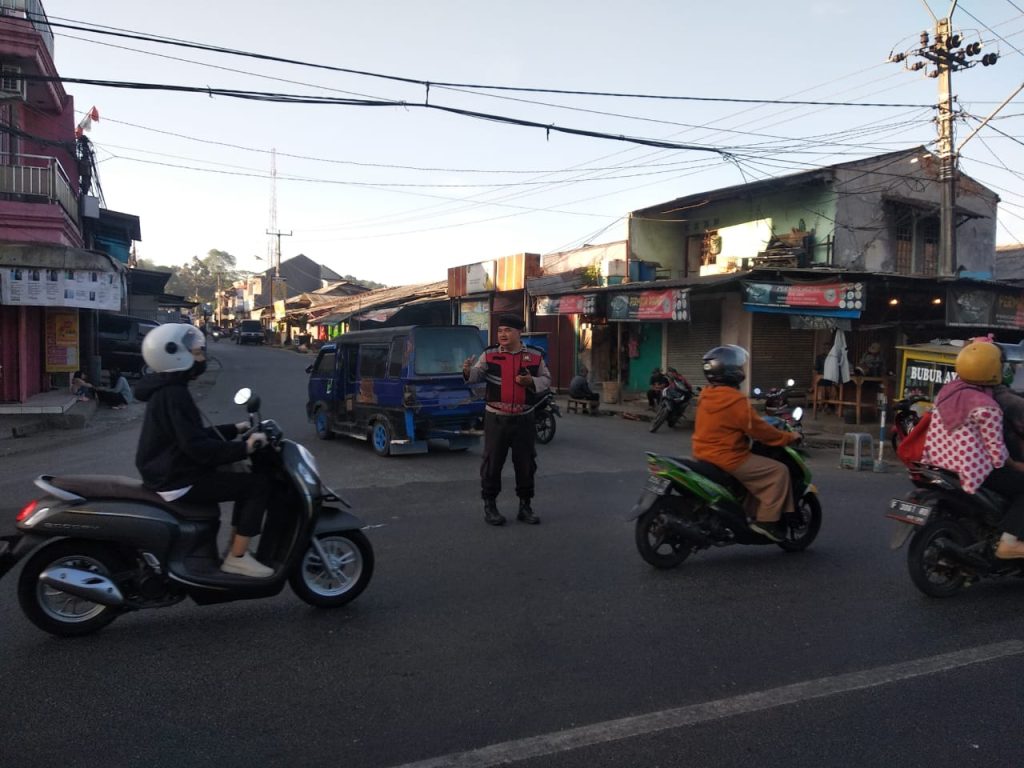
(889, 0), (998, 278)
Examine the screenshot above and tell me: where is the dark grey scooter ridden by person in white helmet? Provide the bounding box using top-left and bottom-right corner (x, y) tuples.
(0, 389), (374, 636)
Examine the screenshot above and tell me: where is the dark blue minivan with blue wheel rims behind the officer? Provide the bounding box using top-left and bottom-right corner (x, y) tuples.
(306, 326), (484, 456)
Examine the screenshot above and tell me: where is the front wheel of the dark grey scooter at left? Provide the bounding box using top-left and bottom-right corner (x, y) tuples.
(288, 530), (374, 608)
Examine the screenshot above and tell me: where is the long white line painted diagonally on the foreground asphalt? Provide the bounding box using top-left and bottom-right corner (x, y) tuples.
(387, 640), (1024, 768)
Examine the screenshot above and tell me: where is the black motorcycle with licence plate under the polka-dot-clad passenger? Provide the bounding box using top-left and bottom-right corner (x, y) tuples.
(886, 464), (1024, 597)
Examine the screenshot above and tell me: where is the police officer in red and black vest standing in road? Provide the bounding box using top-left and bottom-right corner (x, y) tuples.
(462, 314), (551, 525)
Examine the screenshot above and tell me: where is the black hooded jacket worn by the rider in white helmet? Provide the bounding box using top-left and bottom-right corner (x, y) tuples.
(135, 371), (247, 490)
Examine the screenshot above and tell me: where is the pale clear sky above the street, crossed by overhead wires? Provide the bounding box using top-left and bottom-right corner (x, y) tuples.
(44, 0), (1024, 285)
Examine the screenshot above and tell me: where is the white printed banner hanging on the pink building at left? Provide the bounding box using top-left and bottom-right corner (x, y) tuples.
(0, 266), (122, 312)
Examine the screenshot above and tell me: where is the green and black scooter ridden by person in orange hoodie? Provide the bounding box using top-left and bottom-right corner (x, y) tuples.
(629, 408), (821, 568)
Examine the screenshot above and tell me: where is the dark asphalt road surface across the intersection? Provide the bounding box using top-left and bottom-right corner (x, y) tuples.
(0, 343), (1024, 768)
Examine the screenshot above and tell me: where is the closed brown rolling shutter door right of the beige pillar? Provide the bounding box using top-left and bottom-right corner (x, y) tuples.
(750, 312), (814, 391)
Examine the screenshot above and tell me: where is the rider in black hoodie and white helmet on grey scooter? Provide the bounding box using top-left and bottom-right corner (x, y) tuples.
(135, 323), (273, 579)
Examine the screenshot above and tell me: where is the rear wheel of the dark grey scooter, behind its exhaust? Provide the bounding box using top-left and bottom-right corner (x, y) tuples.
(17, 540), (121, 637)
